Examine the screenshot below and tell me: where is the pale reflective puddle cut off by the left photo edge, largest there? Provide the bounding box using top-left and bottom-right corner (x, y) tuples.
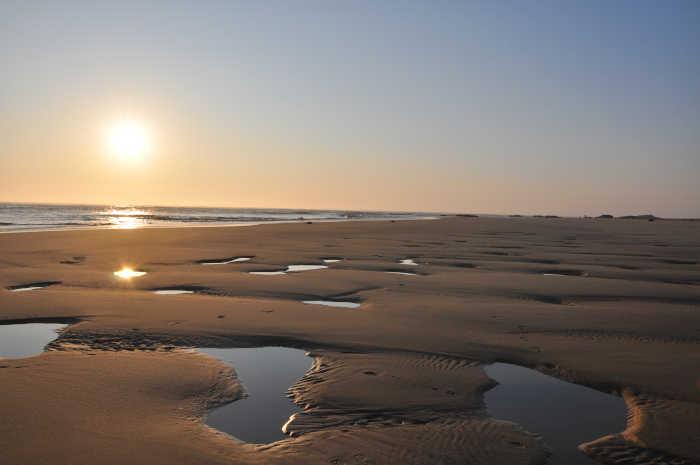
(0, 323), (68, 359)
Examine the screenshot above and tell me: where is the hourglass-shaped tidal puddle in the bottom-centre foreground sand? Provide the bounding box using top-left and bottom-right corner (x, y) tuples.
(197, 347), (311, 444)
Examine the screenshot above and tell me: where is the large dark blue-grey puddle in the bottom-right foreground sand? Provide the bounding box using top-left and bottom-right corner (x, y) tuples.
(484, 363), (627, 465)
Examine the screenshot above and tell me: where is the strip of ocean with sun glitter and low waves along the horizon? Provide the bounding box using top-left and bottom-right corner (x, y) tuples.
(0, 203), (439, 232)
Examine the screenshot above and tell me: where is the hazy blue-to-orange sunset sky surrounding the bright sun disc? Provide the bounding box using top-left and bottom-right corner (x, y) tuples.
(0, 0), (700, 217)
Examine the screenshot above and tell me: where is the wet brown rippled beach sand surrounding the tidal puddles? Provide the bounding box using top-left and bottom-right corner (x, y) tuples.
(0, 217), (700, 465)
